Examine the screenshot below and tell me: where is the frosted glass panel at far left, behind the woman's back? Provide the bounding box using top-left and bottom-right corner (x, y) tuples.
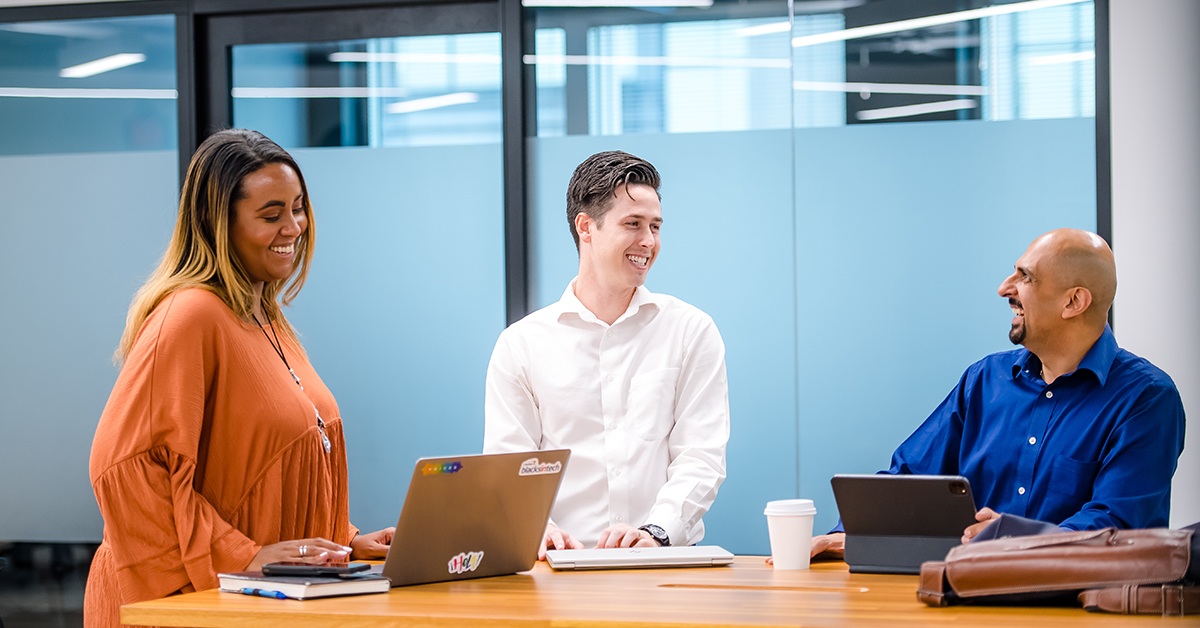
(0, 150), (179, 543)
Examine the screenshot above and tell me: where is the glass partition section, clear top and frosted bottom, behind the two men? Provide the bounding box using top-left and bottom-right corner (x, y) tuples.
(524, 0), (1097, 554)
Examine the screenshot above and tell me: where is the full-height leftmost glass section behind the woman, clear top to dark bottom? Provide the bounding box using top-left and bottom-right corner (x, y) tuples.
(0, 14), (179, 626)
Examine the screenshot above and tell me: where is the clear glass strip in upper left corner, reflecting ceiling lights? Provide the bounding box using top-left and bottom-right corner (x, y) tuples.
(0, 16), (179, 155)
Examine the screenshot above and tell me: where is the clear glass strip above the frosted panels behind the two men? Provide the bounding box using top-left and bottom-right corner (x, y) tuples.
(526, 0), (1096, 132)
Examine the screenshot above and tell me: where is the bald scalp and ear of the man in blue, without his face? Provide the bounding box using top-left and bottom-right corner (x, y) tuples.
(1027, 229), (1117, 325)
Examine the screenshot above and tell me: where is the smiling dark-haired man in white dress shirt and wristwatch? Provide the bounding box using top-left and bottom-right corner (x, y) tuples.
(484, 151), (730, 557)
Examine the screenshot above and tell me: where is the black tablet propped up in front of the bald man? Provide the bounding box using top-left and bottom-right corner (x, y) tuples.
(830, 473), (976, 574)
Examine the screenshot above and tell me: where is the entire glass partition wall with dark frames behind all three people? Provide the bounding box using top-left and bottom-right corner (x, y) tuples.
(0, 0), (1108, 561)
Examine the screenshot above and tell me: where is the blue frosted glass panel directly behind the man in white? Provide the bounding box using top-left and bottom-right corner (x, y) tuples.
(532, 131), (797, 554)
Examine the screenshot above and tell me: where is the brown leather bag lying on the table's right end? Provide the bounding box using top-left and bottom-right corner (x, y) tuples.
(917, 528), (1200, 615)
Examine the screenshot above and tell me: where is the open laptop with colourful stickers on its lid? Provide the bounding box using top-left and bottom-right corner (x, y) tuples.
(382, 449), (571, 586)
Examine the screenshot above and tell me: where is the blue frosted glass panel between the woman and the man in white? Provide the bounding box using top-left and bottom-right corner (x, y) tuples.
(287, 144), (505, 531)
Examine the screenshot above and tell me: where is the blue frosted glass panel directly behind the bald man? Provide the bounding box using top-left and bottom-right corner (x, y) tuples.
(796, 118), (1096, 531)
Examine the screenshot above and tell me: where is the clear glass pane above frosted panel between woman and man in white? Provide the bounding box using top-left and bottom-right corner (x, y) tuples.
(232, 32), (500, 148)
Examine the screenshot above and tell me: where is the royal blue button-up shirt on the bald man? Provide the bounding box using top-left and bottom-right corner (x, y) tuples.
(859, 328), (1183, 530)
